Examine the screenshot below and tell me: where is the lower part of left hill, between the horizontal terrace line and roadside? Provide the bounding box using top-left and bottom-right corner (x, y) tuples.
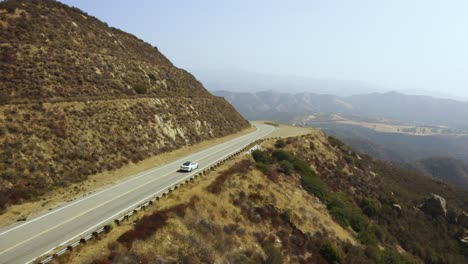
(0, 76), (249, 214)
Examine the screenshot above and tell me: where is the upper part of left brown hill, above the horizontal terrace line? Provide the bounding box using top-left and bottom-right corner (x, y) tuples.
(0, 1), (210, 102)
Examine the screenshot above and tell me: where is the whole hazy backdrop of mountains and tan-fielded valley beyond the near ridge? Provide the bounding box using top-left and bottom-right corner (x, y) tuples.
(215, 91), (468, 187)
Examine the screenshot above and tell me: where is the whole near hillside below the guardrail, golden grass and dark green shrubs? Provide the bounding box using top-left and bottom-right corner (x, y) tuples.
(53, 130), (468, 263)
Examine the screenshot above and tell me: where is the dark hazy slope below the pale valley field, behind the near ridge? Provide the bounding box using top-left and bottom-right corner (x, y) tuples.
(315, 123), (468, 188)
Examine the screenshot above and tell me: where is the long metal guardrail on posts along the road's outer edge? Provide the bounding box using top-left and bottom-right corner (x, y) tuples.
(38, 137), (280, 264)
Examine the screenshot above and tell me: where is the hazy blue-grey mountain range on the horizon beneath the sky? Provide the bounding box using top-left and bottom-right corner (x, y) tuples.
(214, 91), (468, 129)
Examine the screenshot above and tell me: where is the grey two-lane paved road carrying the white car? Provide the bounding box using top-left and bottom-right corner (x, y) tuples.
(0, 124), (275, 264)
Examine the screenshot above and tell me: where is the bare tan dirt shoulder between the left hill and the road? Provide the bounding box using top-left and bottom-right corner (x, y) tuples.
(0, 127), (255, 227)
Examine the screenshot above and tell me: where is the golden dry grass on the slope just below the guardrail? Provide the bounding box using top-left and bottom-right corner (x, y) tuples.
(58, 142), (356, 263)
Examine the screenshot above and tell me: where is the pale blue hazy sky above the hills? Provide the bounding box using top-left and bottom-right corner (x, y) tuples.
(63, 0), (468, 97)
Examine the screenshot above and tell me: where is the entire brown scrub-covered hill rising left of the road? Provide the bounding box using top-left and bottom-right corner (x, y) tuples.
(0, 0), (250, 210)
